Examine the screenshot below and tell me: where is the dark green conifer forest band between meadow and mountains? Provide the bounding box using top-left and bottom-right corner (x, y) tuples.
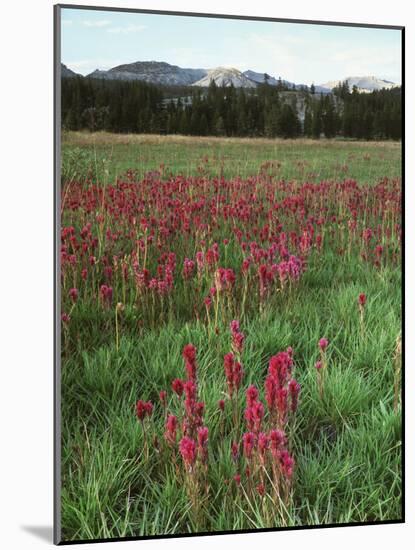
(61, 77), (402, 139)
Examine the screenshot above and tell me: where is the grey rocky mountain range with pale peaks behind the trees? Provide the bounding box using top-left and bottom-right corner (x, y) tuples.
(61, 61), (398, 94)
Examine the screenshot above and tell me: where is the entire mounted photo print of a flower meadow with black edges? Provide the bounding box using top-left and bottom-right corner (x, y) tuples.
(55, 5), (404, 544)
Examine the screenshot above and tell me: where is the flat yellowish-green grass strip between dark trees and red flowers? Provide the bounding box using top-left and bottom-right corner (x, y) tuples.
(63, 132), (401, 183)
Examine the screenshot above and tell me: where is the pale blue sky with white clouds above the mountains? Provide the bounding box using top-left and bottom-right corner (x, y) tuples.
(61, 8), (401, 84)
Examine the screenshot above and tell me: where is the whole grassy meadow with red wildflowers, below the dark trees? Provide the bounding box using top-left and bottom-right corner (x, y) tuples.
(61, 133), (402, 540)
